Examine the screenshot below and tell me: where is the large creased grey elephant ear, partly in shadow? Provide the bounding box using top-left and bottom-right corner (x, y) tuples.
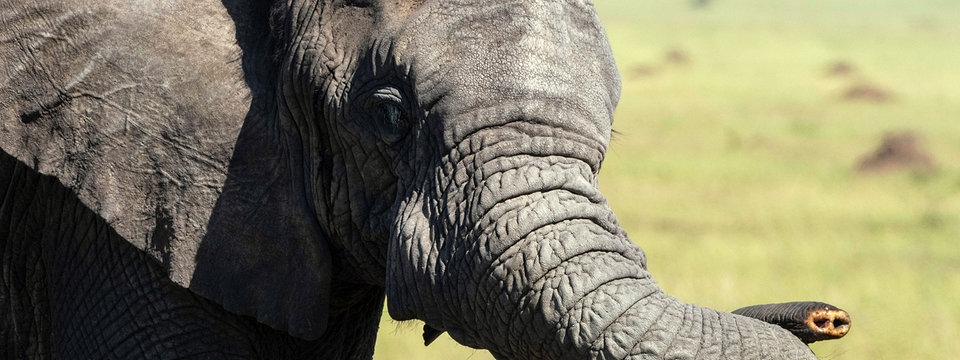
(0, 0), (331, 338)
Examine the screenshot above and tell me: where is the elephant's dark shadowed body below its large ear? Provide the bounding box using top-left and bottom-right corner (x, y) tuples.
(0, 154), (383, 359)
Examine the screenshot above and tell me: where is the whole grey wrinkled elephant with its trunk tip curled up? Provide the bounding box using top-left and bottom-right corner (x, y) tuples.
(0, 0), (849, 359)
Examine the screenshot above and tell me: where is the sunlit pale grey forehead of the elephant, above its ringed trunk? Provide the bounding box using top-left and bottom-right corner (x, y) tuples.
(396, 1), (620, 149)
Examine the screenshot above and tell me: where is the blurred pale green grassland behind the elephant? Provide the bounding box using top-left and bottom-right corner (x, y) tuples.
(375, 0), (960, 360)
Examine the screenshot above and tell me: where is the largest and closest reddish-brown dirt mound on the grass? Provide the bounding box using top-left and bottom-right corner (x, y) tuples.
(857, 131), (937, 173)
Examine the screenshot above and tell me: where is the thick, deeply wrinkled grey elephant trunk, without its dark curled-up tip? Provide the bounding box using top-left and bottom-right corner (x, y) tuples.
(388, 122), (813, 359)
